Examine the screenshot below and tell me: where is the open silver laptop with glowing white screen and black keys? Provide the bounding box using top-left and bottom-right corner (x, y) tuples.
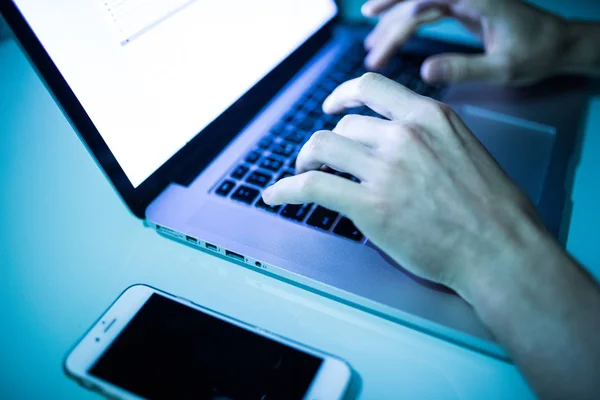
(0, 0), (586, 359)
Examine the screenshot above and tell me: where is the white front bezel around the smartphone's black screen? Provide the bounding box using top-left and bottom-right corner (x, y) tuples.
(63, 285), (352, 400)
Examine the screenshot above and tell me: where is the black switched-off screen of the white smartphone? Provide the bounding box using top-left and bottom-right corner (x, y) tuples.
(89, 294), (323, 400)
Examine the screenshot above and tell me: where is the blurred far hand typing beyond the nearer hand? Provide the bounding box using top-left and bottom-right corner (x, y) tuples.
(362, 0), (575, 86)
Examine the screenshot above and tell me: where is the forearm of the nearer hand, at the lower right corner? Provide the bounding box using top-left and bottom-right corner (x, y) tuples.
(462, 222), (600, 399)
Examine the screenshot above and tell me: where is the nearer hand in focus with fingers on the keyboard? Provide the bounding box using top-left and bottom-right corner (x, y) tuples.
(263, 73), (541, 300)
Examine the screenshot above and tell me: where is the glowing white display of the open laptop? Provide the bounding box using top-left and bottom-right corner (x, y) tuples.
(13, 0), (337, 187)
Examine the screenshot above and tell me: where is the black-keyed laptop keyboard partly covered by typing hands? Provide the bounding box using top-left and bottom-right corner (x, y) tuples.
(214, 43), (444, 242)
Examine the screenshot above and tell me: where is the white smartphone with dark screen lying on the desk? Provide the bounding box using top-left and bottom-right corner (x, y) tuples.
(64, 285), (352, 400)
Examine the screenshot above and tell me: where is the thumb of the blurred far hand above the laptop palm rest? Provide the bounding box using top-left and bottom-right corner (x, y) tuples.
(421, 54), (506, 83)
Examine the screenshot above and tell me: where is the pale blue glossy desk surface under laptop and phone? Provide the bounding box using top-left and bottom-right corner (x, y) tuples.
(0, 20), (600, 399)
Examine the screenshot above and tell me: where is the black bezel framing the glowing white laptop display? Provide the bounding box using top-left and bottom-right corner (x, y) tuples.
(0, 0), (339, 219)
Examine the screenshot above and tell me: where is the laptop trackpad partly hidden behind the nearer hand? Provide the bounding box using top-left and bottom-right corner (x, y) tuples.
(456, 105), (556, 204)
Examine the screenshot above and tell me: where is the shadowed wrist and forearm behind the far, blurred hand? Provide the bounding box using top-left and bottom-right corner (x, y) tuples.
(562, 21), (600, 76)
